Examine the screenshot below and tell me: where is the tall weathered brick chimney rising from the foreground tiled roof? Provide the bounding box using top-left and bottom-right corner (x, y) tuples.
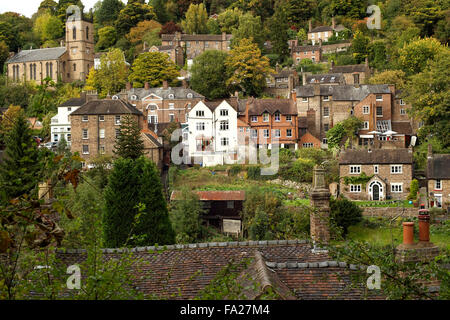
(310, 165), (331, 244)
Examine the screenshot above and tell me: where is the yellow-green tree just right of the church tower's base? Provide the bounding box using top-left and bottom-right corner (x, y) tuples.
(86, 49), (128, 96)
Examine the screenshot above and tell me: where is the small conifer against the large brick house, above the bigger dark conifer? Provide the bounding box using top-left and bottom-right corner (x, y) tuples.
(114, 116), (144, 160)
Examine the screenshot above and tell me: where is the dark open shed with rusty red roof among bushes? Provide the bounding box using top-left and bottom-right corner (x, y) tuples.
(170, 190), (245, 229)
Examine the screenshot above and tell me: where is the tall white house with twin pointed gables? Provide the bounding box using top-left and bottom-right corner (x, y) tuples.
(188, 100), (238, 166)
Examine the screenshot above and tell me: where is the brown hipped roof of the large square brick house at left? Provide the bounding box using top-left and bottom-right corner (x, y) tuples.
(70, 99), (142, 116)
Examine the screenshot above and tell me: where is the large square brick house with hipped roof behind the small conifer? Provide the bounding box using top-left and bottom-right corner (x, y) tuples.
(69, 99), (143, 164)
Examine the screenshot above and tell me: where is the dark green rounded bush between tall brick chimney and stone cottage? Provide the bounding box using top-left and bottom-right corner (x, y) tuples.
(330, 199), (362, 236)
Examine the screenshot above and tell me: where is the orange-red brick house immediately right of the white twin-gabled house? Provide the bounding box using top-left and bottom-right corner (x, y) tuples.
(239, 95), (298, 149)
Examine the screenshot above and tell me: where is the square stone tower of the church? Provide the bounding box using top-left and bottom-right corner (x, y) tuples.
(62, 18), (94, 82)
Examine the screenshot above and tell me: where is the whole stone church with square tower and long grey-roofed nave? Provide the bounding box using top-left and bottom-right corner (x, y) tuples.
(6, 19), (94, 82)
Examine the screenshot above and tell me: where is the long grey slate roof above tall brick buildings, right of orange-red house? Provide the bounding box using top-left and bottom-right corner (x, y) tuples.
(295, 84), (390, 101)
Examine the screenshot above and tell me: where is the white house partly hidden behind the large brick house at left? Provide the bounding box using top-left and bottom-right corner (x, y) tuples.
(50, 96), (86, 145)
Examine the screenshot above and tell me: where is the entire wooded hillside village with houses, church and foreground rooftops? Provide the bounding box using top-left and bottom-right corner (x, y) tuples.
(0, 0), (450, 300)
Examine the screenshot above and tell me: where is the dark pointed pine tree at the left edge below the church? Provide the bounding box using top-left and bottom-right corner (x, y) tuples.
(0, 112), (39, 199)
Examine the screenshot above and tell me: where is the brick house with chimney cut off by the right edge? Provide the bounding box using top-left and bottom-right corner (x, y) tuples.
(426, 145), (450, 210)
